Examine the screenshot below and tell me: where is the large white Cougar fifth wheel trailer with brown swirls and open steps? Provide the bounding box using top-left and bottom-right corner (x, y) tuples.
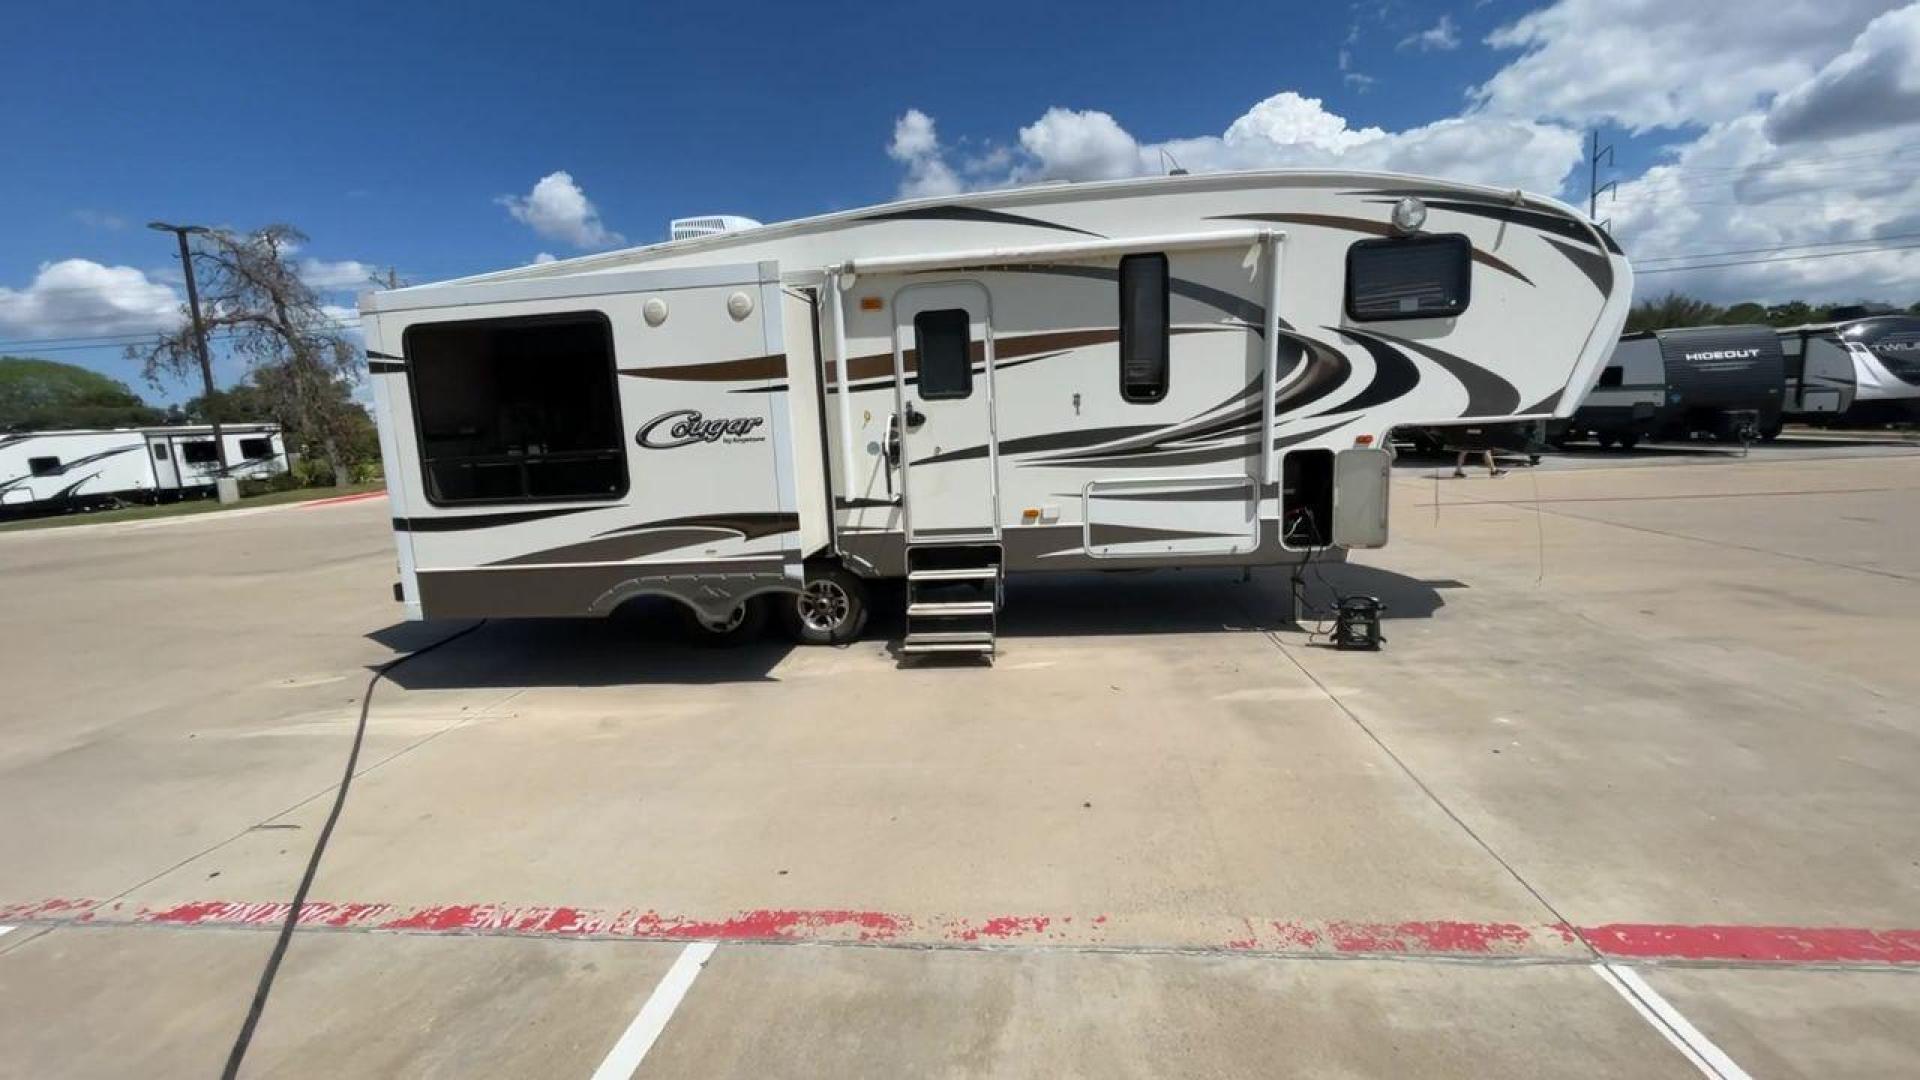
(361, 171), (1632, 657)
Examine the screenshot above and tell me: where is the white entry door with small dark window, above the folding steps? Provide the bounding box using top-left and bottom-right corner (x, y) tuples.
(893, 282), (1000, 544)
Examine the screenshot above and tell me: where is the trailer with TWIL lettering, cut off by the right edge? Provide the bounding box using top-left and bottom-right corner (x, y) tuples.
(1780, 315), (1920, 425)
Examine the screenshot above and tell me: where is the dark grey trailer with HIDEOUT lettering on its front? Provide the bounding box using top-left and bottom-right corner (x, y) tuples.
(1553, 319), (1786, 448)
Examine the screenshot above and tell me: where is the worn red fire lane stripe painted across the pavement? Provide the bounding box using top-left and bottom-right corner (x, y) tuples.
(0, 899), (1920, 965)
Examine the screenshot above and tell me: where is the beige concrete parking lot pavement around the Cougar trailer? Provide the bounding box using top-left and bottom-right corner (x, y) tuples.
(0, 446), (1920, 1076)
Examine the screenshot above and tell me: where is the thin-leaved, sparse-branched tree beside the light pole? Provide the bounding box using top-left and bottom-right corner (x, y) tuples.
(127, 225), (359, 482)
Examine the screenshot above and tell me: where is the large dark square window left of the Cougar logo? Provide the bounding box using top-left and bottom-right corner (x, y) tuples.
(403, 311), (626, 503)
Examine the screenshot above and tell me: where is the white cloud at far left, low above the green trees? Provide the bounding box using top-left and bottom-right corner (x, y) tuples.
(0, 259), (180, 338)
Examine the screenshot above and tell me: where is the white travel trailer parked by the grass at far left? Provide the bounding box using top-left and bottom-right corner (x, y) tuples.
(0, 425), (286, 515)
